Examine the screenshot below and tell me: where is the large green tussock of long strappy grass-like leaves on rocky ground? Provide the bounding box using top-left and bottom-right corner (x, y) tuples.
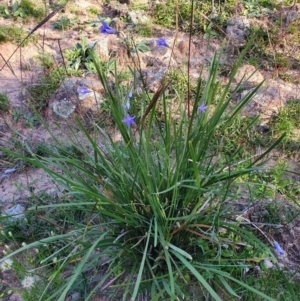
(3, 48), (280, 301)
